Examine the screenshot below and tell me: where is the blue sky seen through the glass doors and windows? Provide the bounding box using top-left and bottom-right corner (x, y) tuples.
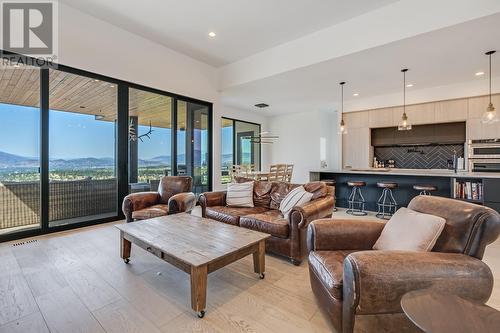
(0, 104), (223, 159)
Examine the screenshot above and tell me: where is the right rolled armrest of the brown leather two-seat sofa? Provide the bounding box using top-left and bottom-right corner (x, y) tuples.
(290, 195), (335, 228)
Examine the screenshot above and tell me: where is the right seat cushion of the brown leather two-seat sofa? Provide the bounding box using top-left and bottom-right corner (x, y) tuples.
(240, 210), (288, 238)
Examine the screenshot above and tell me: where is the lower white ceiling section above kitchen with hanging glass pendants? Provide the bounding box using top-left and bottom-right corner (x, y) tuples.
(223, 14), (500, 115)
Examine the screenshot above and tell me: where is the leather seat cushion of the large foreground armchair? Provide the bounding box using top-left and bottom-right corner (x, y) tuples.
(309, 250), (355, 300)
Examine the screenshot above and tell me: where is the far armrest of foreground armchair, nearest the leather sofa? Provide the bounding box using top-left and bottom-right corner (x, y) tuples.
(307, 218), (385, 251)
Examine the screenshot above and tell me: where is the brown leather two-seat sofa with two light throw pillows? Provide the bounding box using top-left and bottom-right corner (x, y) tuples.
(198, 177), (334, 265)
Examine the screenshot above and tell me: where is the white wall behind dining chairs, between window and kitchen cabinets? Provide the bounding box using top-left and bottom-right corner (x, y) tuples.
(269, 111), (342, 183)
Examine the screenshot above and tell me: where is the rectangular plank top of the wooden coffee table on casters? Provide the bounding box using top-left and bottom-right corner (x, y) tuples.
(116, 213), (270, 266)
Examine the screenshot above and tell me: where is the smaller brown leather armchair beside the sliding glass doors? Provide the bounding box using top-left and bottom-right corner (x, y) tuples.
(122, 176), (196, 222)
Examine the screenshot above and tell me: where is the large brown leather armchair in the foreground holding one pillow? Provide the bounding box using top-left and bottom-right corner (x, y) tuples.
(307, 196), (500, 333)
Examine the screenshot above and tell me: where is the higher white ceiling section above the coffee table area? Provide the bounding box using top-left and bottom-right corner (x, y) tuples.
(57, 0), (397, 67)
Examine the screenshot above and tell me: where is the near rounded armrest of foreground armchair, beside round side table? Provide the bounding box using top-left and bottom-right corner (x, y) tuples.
(343, 251), (493, 316)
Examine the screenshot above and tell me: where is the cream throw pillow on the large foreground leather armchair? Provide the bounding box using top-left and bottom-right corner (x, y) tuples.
(373, 207), (446, 252)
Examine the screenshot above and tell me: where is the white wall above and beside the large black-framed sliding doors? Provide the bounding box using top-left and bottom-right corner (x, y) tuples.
(58, 3), (269, 189)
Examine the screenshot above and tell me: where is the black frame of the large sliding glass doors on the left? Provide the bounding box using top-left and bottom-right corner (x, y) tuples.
(0, 49), (214, 243)
